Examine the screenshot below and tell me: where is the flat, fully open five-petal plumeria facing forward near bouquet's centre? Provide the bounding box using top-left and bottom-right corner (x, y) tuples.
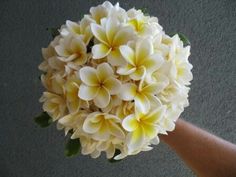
(79, 63), (121, 108)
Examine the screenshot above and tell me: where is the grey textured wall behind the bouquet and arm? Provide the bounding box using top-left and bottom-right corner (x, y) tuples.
(0, 0), (236, 177)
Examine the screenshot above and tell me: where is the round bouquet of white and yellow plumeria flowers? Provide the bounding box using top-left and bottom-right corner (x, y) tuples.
(35, 1), (192, 160)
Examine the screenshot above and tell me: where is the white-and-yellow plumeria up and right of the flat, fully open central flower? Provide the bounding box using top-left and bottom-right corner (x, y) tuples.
(117, 38), (163, 80)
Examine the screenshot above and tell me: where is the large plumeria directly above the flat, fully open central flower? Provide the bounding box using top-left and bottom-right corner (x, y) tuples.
(91, 18), (134, 66)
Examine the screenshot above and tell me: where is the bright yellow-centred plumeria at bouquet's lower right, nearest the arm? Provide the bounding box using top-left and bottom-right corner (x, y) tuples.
(122, 106), (166, 153)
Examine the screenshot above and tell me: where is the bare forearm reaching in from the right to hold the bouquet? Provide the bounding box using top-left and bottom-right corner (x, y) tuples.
(160, 119), (236, 177)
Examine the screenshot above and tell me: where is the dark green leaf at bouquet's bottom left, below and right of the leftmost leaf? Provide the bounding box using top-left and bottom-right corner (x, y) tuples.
(65, 138), (81, 157)
